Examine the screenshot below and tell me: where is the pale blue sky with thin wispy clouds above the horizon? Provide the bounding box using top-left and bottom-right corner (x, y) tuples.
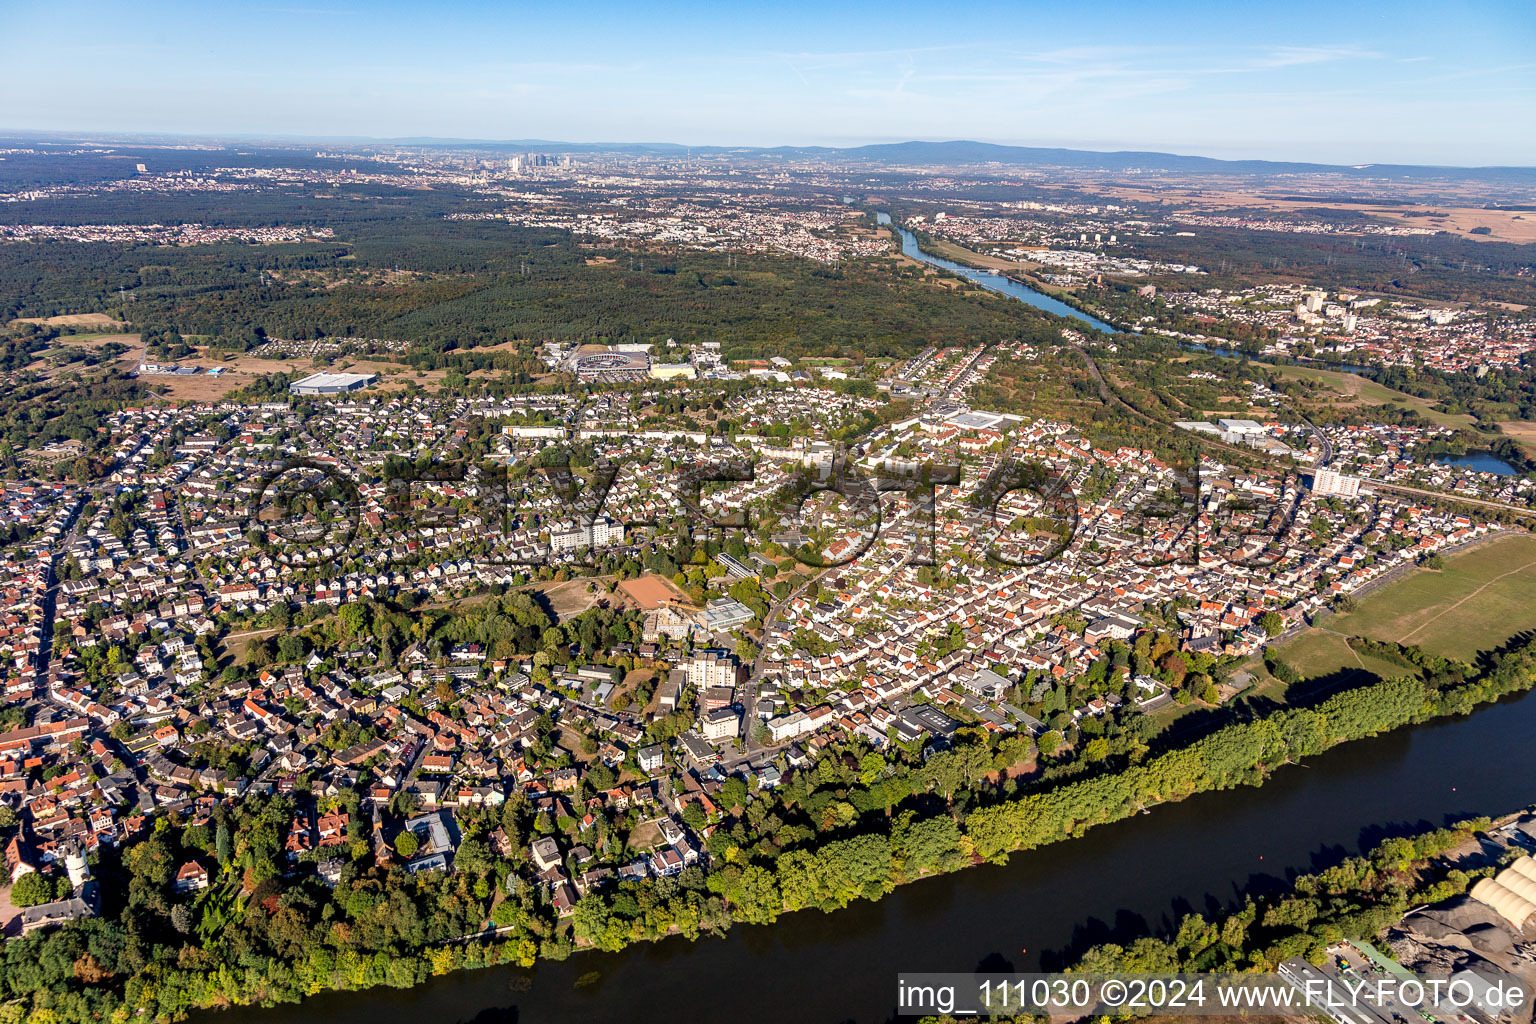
(0, 0), (1536, 164)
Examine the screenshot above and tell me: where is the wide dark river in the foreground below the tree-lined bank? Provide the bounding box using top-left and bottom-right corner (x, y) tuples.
(204, 692), (1536, 1024)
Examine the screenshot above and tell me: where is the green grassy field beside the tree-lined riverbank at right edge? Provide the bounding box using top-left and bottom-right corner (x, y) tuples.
(1279, 533), (1536, 677)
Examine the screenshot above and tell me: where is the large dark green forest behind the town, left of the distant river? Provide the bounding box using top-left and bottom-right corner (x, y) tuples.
(0, 164), (1081, 368)
